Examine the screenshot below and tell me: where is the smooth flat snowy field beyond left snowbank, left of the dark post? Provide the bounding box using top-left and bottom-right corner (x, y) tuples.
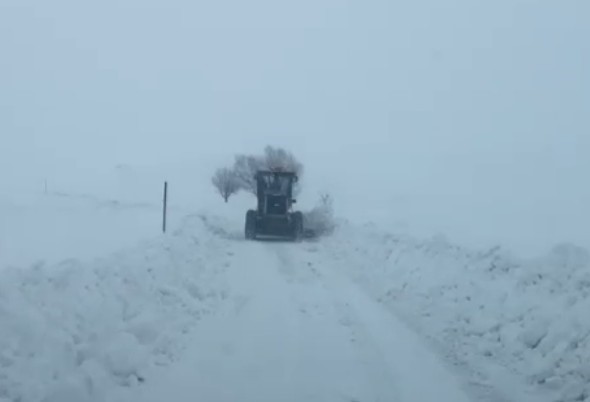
(0, 193), (162, 269)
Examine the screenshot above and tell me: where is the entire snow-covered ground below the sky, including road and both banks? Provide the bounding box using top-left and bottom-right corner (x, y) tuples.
(0, 195), (590, 402)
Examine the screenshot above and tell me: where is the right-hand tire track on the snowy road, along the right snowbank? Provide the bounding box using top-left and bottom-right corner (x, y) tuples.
(280, 242), (476, 402)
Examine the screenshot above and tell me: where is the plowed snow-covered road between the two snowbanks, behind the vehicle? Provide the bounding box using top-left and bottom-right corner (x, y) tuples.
(113, 241), (476, 402)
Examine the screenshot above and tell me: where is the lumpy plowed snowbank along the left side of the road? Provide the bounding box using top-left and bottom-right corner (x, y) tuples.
(0, 217), (226, 402)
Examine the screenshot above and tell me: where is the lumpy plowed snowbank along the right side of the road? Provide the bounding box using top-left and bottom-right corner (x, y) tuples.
(324, 225), (590, 401)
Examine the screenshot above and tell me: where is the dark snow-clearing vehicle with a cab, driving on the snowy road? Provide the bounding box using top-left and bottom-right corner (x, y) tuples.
(245, 170), (303, 240)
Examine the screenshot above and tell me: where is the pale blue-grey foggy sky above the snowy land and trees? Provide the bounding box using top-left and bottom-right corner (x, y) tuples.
(0, 0), (590, 254)
